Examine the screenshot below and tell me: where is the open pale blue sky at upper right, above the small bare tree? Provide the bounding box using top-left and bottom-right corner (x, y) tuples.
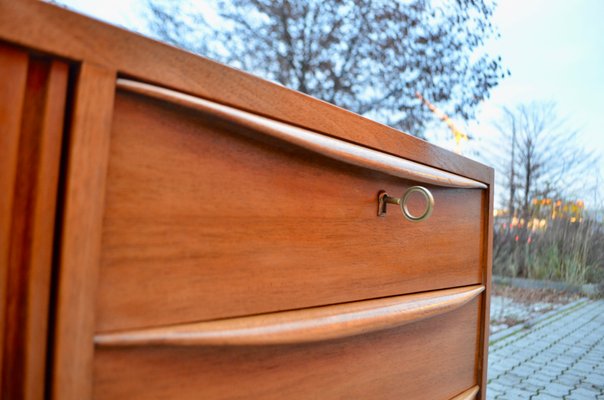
(470, 0), (604, 166)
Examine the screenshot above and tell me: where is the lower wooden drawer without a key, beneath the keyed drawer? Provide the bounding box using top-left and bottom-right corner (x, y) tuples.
(93, 288), (482, 400)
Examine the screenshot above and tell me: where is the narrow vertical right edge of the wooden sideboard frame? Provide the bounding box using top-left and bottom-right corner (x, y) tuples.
(478, 175), (495, 400)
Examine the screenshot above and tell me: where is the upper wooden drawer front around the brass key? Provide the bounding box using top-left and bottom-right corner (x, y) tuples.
(96, 83), (485, 331)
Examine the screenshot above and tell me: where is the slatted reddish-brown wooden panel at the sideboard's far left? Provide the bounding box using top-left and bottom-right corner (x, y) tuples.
(0, 45), (69, 399)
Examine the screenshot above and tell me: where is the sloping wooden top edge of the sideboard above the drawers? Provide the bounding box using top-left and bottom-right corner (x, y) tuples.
(0, 0), (492, 183)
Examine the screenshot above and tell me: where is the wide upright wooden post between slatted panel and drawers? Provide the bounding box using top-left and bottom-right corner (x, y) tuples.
(51, 63), (116, 400)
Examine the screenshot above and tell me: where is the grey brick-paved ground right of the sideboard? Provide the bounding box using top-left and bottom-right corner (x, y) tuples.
(487, 287), (604, 400)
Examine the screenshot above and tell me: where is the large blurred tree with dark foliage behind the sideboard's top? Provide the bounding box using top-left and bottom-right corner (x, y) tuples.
(148, 0), (505, 135)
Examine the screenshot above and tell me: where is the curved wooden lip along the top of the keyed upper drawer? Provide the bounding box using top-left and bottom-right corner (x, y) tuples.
(117, 79), (487, 189)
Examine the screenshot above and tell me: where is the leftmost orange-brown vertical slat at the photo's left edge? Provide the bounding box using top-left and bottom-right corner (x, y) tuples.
(0, 46), (28, 397)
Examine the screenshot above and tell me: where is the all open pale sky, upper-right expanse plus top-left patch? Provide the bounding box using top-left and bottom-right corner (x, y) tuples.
(57, 0), (604, 206)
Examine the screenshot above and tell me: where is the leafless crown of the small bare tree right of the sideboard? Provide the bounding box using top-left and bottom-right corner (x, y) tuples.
(496, 102), (598, 218)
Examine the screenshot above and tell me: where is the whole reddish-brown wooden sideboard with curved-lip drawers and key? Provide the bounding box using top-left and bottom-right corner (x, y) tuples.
(0, 0), (493, 400)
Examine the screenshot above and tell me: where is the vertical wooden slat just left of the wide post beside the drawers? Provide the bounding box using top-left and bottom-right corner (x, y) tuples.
(17, 57), (68, 399)
